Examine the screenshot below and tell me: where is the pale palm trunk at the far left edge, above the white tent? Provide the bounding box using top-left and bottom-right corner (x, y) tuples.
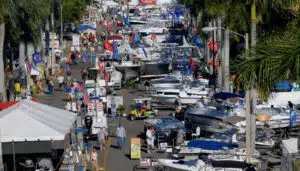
(0, 23), (7, 102)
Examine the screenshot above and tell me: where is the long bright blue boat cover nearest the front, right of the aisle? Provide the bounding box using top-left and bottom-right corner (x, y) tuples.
(187, 140), (238, 150)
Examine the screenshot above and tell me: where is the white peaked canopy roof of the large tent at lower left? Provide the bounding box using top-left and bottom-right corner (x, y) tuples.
(0, 100), (76, 142)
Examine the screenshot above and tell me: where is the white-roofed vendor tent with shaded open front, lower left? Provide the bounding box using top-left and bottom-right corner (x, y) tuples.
(0, 100), (76, 170)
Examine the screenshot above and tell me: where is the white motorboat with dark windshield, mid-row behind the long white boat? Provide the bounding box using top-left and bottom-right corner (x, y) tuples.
(150, 75), (182, 89)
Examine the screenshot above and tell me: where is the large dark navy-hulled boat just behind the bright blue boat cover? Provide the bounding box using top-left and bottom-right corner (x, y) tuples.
(185, 102), (238, 133)
